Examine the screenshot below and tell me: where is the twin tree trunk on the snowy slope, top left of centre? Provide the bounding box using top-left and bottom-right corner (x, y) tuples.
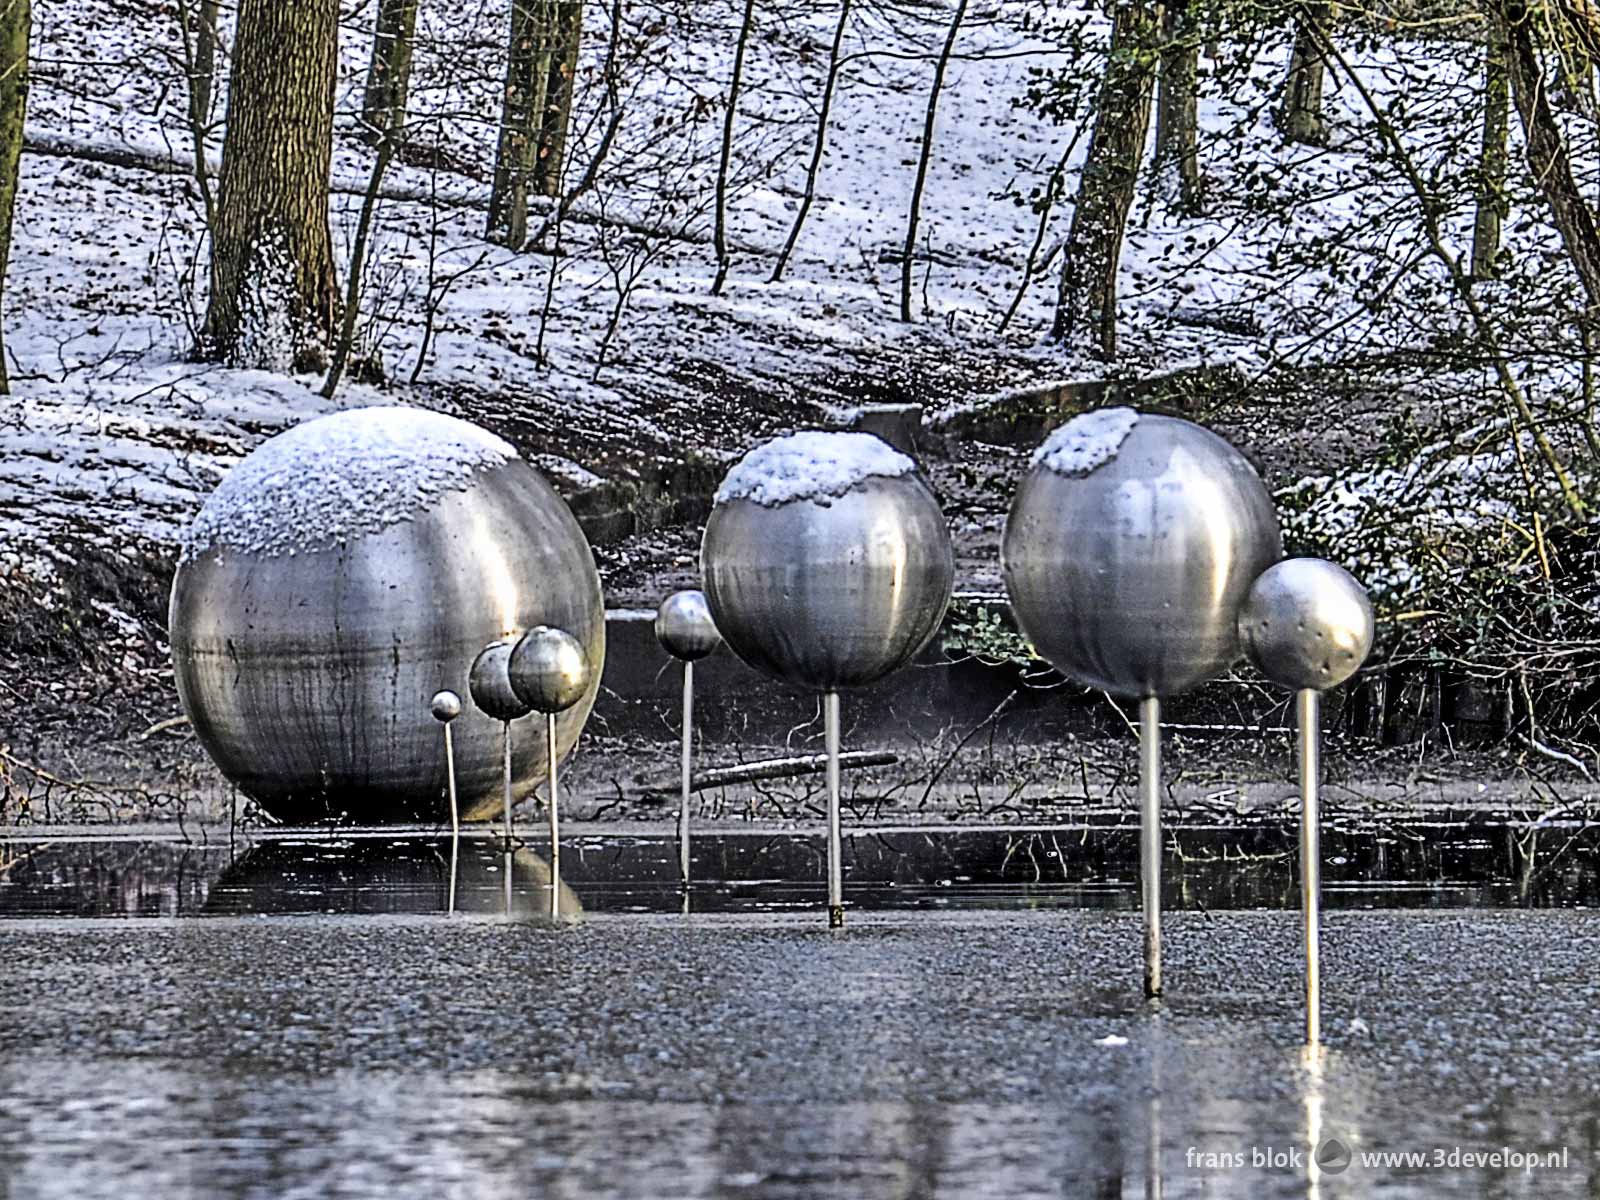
(488, 0), (582, 250)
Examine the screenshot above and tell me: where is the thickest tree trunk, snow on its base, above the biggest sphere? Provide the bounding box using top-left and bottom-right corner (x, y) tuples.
(195, 0), (339, 371)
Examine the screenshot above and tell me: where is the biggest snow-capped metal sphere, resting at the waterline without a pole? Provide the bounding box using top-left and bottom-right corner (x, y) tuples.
(170, 408), (605, 821)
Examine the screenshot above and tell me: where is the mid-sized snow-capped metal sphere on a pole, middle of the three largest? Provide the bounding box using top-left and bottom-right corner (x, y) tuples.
(701, 432), (955, 691)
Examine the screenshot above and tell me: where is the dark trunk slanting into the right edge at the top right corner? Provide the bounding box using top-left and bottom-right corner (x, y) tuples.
(1491, 0), (1600, 314)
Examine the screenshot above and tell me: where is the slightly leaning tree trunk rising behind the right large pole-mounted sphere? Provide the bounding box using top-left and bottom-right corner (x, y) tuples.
(1050, 0), (1160, 362)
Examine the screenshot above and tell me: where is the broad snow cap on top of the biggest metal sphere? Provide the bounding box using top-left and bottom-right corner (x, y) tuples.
(179, 406), (517, 563)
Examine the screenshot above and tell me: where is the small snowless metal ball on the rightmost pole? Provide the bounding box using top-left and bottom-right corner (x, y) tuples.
(1238, 558), (1374, 691)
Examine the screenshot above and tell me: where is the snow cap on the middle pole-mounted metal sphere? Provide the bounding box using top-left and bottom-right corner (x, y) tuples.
(717, 429), (917, 509)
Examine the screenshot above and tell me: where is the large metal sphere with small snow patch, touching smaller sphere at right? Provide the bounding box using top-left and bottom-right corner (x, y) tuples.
(1000, 410), (1282, 698)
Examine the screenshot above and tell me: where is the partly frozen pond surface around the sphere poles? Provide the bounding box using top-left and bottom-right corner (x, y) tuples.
(0, 826), (1600, 1200)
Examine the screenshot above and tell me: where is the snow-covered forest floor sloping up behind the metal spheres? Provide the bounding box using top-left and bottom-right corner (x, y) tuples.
(0, 0), (1595, 822)
